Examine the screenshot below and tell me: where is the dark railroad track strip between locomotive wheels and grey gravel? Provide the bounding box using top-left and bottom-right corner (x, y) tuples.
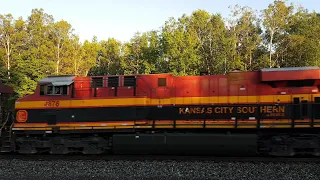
(0, 154), (320, 163)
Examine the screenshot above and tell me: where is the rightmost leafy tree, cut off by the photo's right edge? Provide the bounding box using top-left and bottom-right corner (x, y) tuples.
(277, 9), (320, 66)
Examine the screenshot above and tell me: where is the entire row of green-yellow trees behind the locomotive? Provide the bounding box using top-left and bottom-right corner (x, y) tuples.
(0, 0), (320, 97)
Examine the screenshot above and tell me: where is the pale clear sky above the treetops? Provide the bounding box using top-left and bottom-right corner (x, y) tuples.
(0, 0), (320, 41)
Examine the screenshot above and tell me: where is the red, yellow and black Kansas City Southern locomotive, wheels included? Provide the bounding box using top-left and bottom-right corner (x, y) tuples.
(3, 67), (320, 156)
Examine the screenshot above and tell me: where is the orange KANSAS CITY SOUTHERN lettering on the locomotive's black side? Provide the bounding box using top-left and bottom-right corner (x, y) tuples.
(179, 106), (285, 116)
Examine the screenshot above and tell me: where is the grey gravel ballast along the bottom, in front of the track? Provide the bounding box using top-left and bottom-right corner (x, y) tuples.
(0, 160), (320, 180)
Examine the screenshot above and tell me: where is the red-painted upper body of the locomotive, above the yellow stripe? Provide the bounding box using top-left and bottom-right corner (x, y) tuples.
(14, 66), (320, 101)
